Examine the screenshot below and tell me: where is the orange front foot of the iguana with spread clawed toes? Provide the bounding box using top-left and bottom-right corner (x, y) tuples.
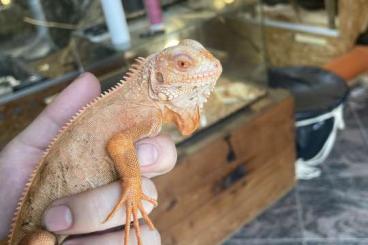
(103, 178), (157, 245)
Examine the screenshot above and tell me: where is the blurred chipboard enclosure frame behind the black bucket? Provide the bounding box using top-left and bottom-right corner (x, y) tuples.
(264, 0), (368, 66)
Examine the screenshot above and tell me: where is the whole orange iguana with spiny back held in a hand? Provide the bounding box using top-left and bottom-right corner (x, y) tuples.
(5, 40), (222, 245)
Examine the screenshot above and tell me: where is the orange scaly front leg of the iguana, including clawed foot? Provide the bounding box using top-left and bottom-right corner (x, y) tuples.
(104, 131), (157, 245)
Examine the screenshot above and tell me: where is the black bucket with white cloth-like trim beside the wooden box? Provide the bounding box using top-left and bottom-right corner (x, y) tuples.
(268, 66), (349, 178)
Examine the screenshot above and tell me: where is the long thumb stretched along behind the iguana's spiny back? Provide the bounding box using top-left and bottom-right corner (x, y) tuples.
(0, 73), (100, 172)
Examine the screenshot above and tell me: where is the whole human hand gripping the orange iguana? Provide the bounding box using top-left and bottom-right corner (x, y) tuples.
(0, 73), (176, 244)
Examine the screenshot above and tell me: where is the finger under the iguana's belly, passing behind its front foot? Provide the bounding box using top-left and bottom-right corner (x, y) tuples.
(44, 178), (157, 234)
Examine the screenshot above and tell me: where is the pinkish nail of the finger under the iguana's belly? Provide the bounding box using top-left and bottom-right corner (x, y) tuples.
(44, 205), (73, 231)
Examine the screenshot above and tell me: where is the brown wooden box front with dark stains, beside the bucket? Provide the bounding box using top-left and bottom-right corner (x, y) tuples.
(152, 90), (295, 245)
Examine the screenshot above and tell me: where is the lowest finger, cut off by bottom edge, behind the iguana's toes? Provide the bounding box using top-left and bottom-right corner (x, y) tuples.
(63, 225), (161, 245)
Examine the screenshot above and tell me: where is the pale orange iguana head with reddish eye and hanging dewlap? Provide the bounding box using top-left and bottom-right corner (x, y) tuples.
(148, 39), (222, 135)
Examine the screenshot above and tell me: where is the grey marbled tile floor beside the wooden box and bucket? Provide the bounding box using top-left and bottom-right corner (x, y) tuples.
(224, 81), (368, 245)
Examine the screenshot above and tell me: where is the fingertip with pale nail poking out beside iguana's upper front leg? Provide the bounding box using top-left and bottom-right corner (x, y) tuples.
(136, 135), (177, 178)
